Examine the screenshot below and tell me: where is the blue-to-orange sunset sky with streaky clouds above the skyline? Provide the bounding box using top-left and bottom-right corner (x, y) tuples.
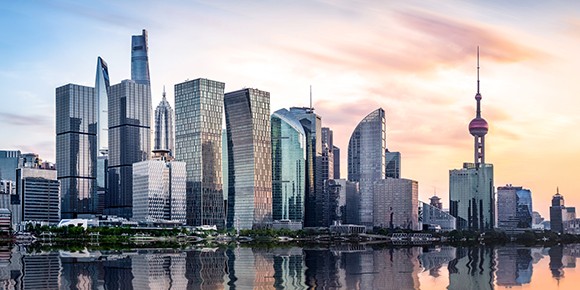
(0, 0), (580, 218)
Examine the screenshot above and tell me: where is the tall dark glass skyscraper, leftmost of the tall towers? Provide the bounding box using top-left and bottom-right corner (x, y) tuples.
(56, 84), (98, 218)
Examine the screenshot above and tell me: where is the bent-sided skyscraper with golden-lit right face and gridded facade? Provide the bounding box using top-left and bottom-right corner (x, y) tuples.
(225, 89), (272, 229)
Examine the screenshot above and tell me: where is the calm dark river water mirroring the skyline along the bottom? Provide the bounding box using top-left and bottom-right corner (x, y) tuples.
(0, 245), (580, 290)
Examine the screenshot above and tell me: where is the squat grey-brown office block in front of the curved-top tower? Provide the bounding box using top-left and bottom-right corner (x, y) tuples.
(373, 178), (419, 230)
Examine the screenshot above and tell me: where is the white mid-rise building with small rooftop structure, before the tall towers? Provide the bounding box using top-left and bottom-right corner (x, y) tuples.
(133, 151), (186, 223)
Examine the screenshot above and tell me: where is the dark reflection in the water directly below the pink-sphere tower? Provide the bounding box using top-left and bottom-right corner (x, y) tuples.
(447, 246), (495, 290)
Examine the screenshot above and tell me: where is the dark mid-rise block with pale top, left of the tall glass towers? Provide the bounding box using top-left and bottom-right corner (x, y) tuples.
(11, 166), (61, 230)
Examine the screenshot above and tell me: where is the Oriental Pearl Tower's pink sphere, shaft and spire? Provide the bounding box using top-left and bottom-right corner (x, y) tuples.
(469, 47), (489, 169)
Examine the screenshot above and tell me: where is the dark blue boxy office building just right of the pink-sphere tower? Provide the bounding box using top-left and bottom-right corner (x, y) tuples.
(497, 184), (532, 229)
